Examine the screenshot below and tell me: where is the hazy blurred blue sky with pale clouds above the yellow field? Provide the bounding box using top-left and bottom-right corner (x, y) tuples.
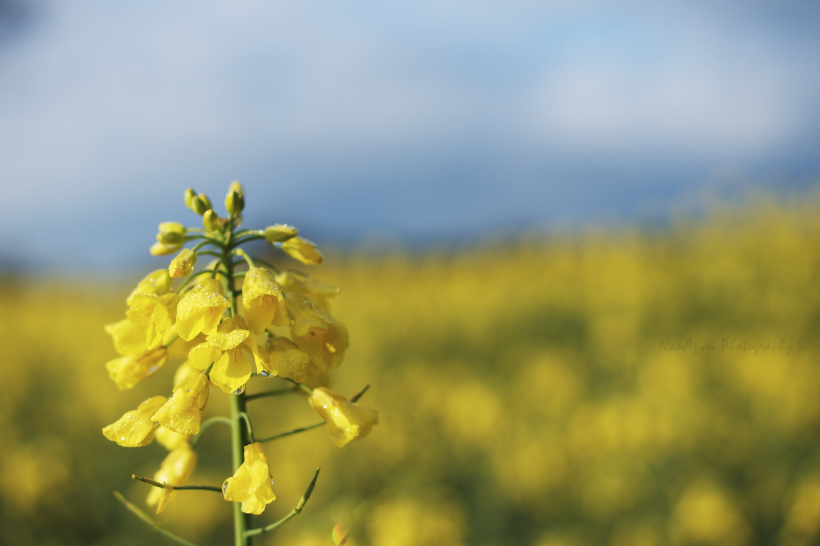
(0, 0), (820, 271)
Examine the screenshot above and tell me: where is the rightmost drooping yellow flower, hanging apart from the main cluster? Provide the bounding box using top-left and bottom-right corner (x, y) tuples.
(308, 387), (379, 447)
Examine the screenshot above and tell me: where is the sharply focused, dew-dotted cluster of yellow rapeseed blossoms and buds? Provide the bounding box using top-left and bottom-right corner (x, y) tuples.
(103, 182), (378, 536)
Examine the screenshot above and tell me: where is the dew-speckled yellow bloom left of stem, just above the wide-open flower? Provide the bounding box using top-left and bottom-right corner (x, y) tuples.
(176, 278), (231, 341)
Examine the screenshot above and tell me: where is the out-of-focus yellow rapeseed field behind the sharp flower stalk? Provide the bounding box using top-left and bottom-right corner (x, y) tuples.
(0, 198), (820, 546)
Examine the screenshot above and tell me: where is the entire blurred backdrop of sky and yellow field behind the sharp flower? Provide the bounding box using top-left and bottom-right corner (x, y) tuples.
(0, 0), (820, 546)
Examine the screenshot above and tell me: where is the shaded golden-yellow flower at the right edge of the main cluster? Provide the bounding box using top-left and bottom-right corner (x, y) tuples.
(285, 292), (350, 372)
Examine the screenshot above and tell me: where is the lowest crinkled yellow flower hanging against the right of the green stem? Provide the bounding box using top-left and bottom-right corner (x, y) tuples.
(222, 442), (276, 516)
